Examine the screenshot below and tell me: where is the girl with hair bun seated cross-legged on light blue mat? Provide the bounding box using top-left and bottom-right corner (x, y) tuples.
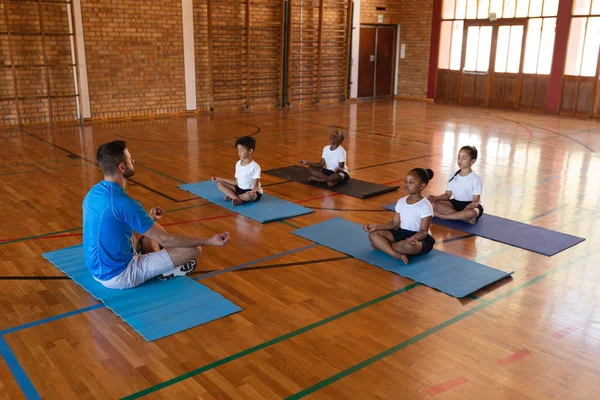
(363, 168), (435, 264)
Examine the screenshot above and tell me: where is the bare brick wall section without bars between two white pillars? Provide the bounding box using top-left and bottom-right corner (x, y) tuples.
(81, 0), (185, 118)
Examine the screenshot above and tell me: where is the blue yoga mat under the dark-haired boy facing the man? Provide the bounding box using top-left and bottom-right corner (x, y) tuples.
(179, 181), (314, 224)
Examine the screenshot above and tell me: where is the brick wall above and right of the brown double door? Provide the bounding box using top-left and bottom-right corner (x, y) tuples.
(360, 0), (433, 98)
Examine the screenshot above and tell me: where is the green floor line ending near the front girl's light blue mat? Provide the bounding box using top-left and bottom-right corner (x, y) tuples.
(123, 283), (420, 400)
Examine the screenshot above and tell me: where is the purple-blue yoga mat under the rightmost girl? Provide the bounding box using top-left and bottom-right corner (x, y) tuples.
(383, 203), (585, 256)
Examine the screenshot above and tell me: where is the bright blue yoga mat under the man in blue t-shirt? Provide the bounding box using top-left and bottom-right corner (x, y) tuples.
(43, 244), (242, 342)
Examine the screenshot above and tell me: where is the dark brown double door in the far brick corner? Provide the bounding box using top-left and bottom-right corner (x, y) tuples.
(358, 26), (396, 98)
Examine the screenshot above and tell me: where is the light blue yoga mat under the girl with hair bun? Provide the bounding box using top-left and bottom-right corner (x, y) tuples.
(292, 217), (512, 298)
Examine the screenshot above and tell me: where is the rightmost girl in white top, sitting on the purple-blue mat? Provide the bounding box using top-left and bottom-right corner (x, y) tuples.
(428, 146), (483, 224)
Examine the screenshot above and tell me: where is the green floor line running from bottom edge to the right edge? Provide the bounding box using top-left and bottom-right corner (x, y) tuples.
(286, 249), (600, 400)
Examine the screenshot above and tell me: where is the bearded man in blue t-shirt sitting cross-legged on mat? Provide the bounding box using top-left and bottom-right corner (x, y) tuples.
(83, 140), (229, 289)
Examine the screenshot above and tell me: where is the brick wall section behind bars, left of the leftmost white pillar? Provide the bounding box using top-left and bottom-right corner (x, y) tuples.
(0, 2), (77, 125)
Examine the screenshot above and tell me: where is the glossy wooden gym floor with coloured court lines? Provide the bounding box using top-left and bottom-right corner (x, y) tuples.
(0, 101), (600, 400)
